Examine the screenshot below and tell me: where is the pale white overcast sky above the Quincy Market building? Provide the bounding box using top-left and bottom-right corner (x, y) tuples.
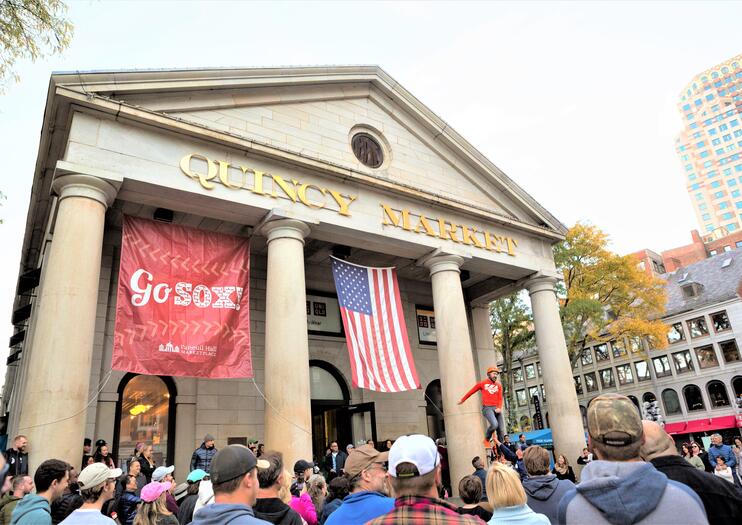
(0, 1), (742, 376)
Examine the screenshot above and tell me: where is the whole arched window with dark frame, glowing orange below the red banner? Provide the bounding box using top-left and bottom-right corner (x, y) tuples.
(113, 374), (177, 465)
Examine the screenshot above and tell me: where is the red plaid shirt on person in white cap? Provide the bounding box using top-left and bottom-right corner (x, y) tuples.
(366, 496), (482, 525)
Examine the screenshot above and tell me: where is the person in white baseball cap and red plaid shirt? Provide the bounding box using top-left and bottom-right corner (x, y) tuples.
(368, 434), (482, 525)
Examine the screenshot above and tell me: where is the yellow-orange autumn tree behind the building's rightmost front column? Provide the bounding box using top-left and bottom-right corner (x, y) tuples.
(554, 223), (667, 367)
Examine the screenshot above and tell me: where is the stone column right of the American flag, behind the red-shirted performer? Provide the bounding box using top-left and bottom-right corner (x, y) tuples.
(424, 255), (484, 495)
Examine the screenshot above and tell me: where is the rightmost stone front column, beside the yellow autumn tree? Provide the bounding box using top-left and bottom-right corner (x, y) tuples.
(526, 276), (585, 468)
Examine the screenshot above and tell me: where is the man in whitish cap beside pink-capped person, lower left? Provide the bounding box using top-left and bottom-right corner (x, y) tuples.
(61, 463), (123, 525)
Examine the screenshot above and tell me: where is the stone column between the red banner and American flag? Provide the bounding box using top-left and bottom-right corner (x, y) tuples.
(262, 219), (312, 465)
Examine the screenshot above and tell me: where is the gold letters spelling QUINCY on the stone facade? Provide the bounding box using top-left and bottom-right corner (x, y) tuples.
(180, 153), (358, 217)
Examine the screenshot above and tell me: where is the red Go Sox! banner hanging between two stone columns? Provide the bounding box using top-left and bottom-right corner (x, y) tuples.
(111, 216), (252, 378)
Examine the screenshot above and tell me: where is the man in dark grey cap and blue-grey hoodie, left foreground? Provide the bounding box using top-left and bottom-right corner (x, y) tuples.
(191, 445), (270, 525)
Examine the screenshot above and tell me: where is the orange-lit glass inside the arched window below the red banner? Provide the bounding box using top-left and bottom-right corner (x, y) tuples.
(118, 375), (172, 465)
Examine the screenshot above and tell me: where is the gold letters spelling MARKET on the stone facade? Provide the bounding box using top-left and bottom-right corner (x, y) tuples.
(380, 203), (518, 257)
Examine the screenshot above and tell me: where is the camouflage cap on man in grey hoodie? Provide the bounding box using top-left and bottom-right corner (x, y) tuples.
(587, 394), (644, 447)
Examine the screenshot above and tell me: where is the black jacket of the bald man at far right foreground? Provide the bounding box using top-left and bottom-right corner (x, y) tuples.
(651, 456), (742, 525)
